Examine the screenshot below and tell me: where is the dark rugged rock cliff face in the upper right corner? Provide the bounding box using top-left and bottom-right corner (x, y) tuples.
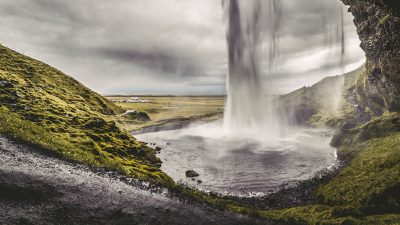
(342, 0), (400, 116)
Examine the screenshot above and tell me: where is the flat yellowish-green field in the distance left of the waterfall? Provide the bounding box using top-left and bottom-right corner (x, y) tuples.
(106, 96), (225, 131)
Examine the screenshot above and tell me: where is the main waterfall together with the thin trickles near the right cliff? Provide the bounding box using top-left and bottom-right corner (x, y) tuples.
(222, 0), (345, 133)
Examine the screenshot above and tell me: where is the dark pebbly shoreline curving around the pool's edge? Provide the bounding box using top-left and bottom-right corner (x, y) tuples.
(131, 121), (348, 210)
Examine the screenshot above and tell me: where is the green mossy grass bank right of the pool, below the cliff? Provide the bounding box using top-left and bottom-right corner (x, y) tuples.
(253, 113), (400, 225)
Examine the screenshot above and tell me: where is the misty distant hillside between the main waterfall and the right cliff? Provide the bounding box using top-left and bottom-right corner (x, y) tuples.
(279, 66), (365, 127)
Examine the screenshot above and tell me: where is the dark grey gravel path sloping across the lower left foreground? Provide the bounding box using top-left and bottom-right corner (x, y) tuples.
(0, 136), (269, 225)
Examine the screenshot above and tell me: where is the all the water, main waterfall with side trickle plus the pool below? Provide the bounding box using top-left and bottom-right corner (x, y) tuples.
(137, 0), (345, 195)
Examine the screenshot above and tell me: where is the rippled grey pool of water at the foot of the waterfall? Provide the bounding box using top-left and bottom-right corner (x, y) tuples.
(135, 122), (337, 195)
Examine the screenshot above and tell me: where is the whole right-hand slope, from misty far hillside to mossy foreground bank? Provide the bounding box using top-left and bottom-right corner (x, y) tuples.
(259, 67), (400, 225)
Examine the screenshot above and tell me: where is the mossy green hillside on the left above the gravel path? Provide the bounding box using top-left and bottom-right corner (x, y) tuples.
(0, 45), (170, 182)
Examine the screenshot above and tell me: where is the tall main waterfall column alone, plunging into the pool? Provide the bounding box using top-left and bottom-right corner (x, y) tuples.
(224, 0), (280, 132)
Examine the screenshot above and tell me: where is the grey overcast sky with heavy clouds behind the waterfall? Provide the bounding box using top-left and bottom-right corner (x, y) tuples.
(0, 0), (364, 94)
